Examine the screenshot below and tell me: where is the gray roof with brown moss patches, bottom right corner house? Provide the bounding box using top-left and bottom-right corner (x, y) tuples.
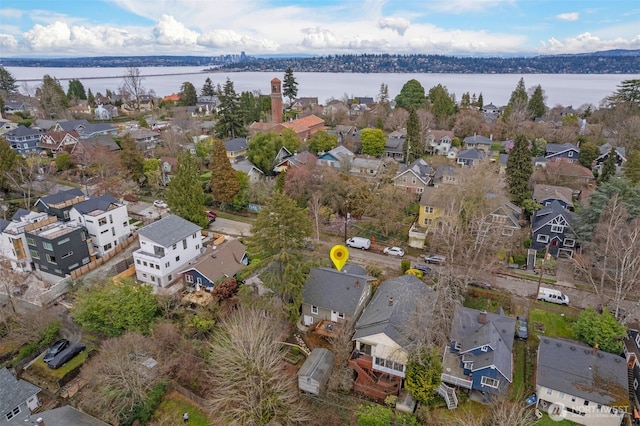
(536, 337), (629, 405)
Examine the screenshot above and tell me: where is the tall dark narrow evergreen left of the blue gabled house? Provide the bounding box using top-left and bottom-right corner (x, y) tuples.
(506, 135), (533, 206)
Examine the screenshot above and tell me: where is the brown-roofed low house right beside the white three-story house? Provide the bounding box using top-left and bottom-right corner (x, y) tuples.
(180, 240), (249, 291)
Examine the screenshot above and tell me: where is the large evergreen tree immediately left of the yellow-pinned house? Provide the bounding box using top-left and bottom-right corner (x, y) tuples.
(247, 192), (312, 321)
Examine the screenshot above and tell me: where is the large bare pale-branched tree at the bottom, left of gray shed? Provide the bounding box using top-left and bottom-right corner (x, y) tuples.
(209, 308), (310, 425)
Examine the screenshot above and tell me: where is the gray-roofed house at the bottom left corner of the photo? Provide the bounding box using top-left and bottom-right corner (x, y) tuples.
(0, 368), (42, 424)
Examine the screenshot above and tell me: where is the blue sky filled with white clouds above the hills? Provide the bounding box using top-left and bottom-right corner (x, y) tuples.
(0, 0), (640, 57)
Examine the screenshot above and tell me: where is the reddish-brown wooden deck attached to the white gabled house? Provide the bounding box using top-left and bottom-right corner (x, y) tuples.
(349, 351), (402, 401)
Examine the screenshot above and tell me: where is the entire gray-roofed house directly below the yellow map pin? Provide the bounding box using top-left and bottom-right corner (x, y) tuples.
(302, 264), (376, 327)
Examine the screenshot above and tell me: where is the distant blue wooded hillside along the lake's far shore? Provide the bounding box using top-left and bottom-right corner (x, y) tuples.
(0, 49), (640, 74)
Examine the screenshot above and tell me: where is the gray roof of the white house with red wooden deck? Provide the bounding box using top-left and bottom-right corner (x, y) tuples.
(353, 274), (433, 348)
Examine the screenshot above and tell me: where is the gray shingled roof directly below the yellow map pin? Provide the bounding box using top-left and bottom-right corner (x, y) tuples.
(302, 268), (375, 315)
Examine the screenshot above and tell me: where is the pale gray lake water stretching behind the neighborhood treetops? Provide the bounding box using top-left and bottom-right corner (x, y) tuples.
(5, 67), (640, 108)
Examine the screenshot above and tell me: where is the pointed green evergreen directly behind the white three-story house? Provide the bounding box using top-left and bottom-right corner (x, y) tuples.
(166, 151), (208, 227)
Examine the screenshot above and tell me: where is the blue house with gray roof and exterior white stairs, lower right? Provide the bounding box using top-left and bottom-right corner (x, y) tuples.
(441, 306), (516, 400)
